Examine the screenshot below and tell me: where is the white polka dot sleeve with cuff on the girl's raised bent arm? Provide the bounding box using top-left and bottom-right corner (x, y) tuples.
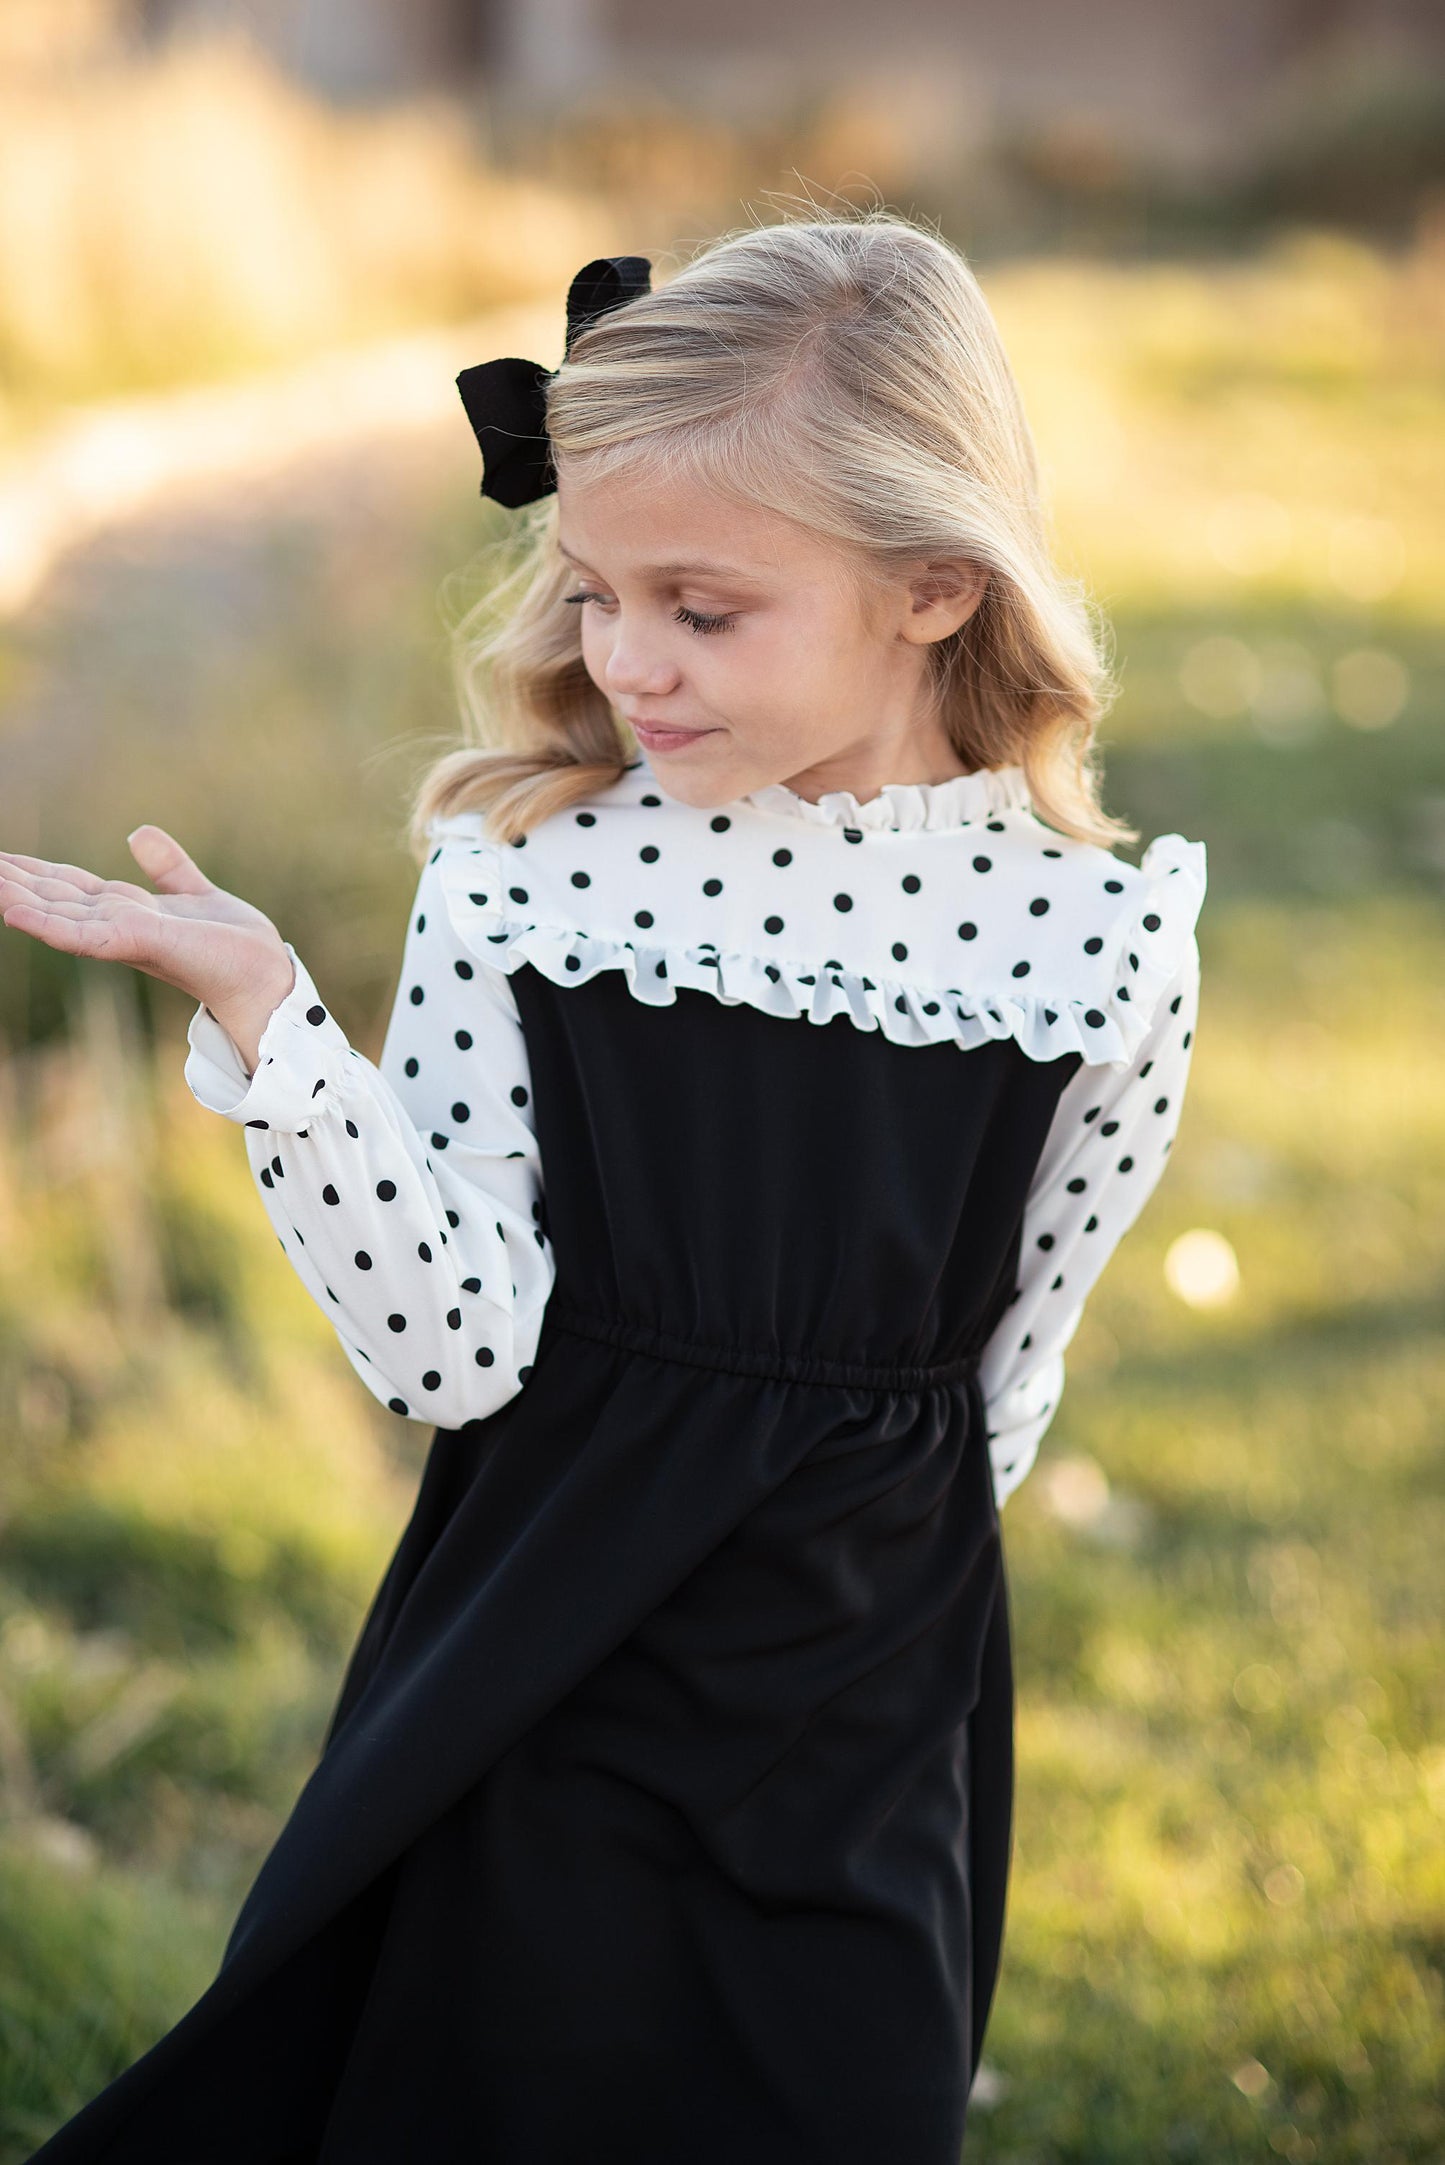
(186, 853), (555, 1429)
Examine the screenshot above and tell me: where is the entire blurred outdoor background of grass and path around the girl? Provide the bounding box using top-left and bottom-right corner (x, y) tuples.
(0, 0), (1445, 2165)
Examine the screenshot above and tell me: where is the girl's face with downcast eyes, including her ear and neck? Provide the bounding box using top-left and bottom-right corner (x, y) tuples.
(557, 459), (986, 808)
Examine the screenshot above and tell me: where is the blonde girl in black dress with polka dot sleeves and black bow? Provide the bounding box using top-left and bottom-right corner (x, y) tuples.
(0, 214), (1205, 2165)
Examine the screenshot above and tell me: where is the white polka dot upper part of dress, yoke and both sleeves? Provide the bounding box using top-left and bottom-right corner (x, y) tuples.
(186, 756), (1205, 1505)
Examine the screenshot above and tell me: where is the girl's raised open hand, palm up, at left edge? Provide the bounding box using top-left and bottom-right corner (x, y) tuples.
(0, 827), (295, 1067)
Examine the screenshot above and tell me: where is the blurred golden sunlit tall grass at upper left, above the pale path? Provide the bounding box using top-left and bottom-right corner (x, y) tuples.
(0, 37), (607, 430)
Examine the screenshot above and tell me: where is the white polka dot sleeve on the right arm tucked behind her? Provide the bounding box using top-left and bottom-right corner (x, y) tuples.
(979, 937), (1200, 1507)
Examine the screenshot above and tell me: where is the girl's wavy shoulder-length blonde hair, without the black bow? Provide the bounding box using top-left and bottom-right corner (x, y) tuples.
(409, 206), (1137, 862)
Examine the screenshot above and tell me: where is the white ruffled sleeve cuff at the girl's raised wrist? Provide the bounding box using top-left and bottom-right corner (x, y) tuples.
(186, 940), (351, 1134)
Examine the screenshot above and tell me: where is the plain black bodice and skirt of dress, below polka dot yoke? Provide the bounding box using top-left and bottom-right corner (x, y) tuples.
(35, 966), (1081, 2165)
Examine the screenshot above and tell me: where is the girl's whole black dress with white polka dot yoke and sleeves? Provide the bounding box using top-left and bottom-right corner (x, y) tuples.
(37, 758), (1205, 2165)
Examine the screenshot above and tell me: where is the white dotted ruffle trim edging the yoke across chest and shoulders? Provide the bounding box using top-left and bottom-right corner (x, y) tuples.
(438, 822), (1207, 1067)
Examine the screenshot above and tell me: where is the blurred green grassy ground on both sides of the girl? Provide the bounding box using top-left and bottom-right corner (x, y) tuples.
(0, 236), (1445, 2165)
